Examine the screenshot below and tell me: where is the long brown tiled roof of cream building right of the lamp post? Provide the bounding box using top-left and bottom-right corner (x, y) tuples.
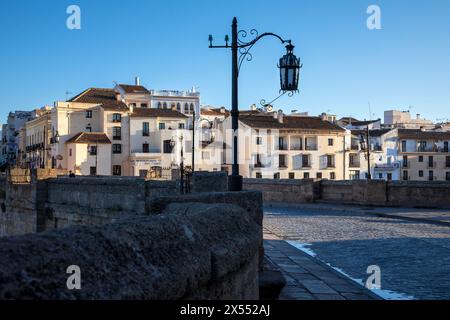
(239, 114), (345, 132)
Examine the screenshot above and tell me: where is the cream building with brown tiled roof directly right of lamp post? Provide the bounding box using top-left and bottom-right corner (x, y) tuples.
(224, 112), (346, 180)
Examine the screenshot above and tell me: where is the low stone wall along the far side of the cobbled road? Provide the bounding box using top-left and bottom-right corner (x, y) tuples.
(244, 179), (450, 208)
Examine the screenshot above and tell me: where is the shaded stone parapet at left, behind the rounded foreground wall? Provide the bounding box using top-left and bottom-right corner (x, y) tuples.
(0, 177), (178, 236)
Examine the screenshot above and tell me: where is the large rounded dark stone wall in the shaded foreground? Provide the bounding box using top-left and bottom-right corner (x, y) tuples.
(0, 202), (261, 300)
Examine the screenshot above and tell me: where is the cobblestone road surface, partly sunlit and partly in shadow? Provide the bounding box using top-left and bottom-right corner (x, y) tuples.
(264, 205), (450, 299)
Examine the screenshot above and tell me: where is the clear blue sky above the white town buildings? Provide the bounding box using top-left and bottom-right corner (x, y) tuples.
(0, 0), (450, 121)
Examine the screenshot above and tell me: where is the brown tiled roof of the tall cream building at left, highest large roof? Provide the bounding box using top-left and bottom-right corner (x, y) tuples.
(68, 88), (128, 111)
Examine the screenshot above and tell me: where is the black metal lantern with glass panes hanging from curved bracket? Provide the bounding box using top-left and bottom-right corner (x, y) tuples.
(278, 43), (302, 92)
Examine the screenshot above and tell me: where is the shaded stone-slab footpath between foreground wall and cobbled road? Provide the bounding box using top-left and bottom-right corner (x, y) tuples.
(264, 232), (377, 300)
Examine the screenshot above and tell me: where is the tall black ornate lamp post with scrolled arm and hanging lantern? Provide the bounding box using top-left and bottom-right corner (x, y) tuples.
(209, 18), (302, 191)
